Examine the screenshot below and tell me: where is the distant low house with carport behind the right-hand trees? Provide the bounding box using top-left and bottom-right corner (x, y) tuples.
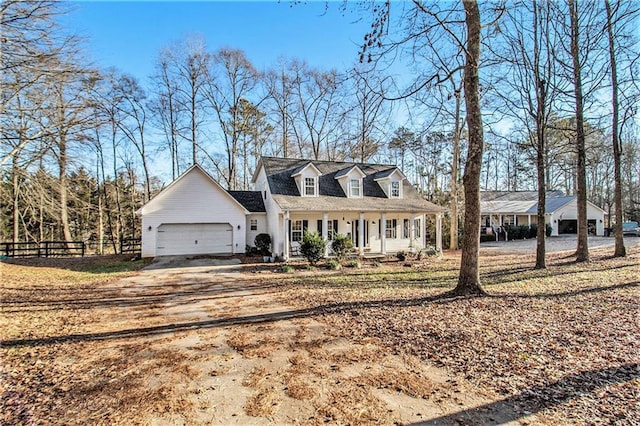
(480, 191), (605, 236)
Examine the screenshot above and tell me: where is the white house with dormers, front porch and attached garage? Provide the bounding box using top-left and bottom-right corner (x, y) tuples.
(138, 157), (445, 258)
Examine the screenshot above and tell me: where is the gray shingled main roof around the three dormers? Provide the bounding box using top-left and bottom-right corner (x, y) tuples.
(262, 157), (445, 213)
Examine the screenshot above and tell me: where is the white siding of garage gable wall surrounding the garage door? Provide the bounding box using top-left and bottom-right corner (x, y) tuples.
(140, 167), (246, 257)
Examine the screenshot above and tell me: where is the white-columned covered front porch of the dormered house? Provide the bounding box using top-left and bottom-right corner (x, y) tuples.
(281, 211), (442, 259)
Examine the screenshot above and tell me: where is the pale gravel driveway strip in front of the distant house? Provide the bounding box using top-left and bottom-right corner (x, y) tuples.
(480, 235), (640, 253)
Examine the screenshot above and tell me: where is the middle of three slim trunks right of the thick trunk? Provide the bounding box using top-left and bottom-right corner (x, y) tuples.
(569, 0), (589, 262)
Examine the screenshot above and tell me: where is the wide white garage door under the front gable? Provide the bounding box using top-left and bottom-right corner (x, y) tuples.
(156, 223), (233, 256)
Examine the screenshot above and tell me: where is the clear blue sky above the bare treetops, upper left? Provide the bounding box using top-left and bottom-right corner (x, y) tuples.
(62, 1), (370, 79)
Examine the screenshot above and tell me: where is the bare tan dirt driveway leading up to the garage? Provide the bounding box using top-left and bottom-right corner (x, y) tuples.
(102, 261), (531, 425)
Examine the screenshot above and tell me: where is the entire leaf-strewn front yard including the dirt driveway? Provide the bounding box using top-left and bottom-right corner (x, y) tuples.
(0, 248), (640, 425)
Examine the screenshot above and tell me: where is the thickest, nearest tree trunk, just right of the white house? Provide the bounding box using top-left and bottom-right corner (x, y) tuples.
(453, 0), (484, 295)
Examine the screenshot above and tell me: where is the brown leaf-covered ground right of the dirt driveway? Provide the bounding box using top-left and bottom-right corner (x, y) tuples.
(280, 248), (640, 425)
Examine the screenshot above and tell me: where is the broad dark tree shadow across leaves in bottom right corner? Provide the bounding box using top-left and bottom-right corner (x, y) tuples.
(413, 363), (640, 426)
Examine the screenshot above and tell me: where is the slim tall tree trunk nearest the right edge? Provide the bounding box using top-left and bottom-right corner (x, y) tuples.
(604, 0), (627, 257)
